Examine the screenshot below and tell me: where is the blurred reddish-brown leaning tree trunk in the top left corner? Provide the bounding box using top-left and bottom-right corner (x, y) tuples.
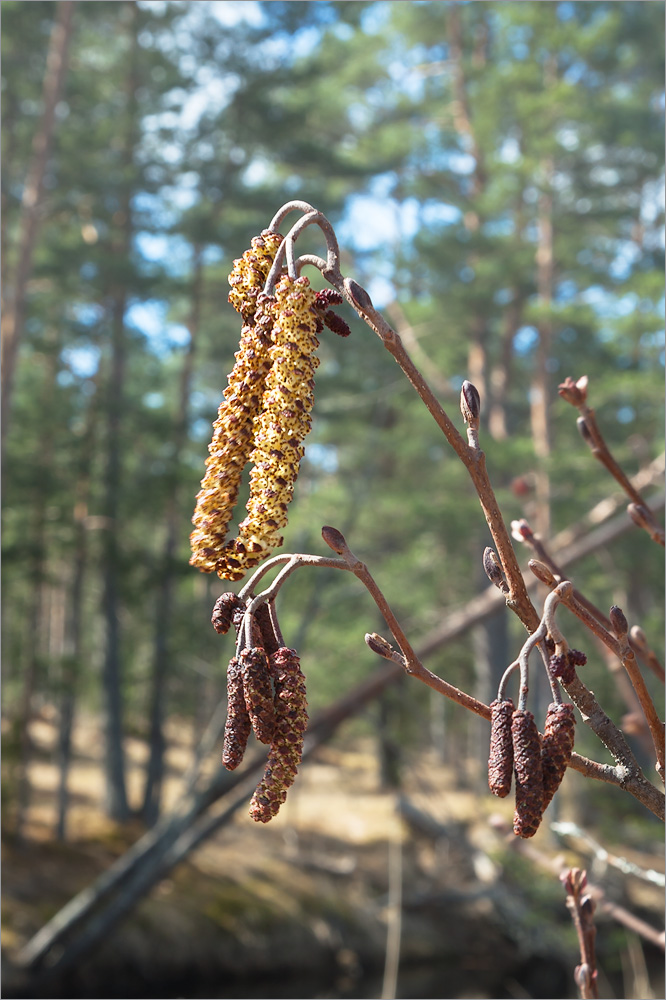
(2, 0), (74, 447)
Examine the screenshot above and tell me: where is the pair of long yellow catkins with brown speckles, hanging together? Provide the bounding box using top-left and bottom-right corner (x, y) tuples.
(190, 230), (349, 580)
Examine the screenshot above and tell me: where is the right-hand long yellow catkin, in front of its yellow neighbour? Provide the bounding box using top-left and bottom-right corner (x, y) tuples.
(217, 275), (328, 579)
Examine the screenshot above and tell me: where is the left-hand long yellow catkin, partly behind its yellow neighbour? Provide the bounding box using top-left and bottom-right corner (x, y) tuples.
(190, 230), (282, 579)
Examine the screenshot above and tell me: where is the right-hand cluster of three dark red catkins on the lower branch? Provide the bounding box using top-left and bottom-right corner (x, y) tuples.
(488, 649), (585, 838)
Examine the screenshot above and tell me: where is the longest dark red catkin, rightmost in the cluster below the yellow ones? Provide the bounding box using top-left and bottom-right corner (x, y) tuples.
(250, 647), (308, 823)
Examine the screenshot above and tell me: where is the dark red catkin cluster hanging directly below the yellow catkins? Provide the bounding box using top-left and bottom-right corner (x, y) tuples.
(212, 594), (308, 823)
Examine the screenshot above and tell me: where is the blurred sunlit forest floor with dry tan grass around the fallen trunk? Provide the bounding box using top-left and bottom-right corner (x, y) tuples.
(2, 711), (663, 998)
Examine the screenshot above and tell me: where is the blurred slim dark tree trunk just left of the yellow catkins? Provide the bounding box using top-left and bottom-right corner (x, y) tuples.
(142, 246), (203, 824)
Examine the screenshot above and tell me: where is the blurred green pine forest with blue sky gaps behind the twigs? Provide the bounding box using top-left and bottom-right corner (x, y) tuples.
(2, 0), (664, 996)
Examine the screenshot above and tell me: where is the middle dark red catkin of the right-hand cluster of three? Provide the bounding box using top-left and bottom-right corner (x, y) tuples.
(511, 708), (543, 838)
